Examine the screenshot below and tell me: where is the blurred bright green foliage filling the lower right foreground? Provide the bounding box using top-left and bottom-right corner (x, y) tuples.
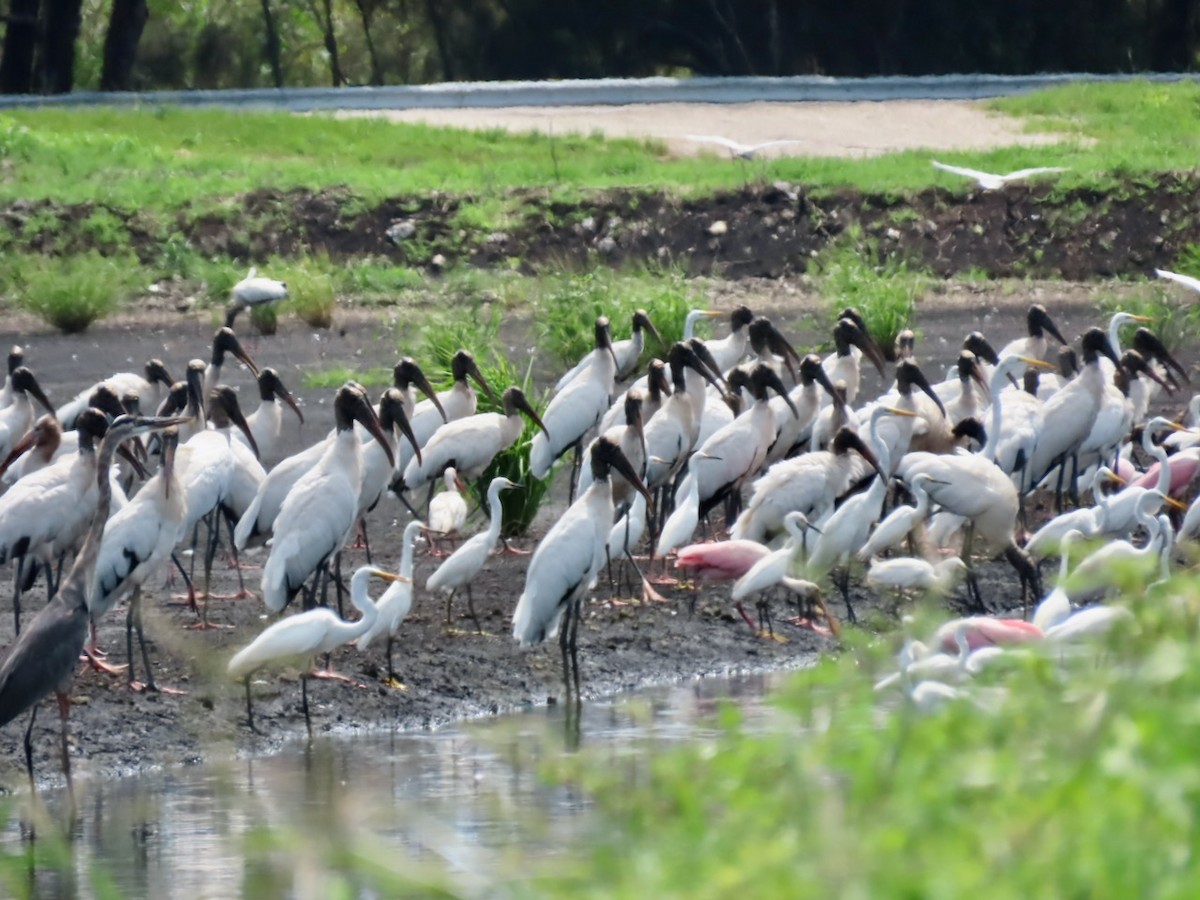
(530, 571), (1200, 898)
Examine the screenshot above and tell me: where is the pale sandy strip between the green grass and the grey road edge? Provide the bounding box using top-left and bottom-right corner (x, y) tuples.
(338, 100), (1061, 157)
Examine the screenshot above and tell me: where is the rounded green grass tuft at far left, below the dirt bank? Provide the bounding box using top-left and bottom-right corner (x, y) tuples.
(4, 251), (139, 334)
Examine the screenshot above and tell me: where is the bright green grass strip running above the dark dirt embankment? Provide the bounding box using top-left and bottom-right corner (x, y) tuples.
(0, 82), (1200, 227)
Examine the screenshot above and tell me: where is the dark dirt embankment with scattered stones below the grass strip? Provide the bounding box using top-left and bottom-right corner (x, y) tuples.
(0, 174), (1200, 281)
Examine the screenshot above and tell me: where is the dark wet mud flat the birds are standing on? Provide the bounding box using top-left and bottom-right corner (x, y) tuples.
(0, 280), (1195, 788)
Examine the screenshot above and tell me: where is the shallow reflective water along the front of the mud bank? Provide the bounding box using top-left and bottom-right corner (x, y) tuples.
(2, 674), (796, 898)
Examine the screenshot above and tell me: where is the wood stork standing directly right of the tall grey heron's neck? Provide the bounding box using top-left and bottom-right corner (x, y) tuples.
(89, 426), (187, 691)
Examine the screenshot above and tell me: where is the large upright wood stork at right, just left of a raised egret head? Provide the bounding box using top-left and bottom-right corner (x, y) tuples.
(1025, 328), (1120, 505)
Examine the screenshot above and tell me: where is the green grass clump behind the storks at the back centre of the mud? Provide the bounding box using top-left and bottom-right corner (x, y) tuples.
(530, 269), (707, 367)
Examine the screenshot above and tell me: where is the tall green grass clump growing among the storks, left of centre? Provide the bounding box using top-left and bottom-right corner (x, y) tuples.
(421, 305), (550, 536)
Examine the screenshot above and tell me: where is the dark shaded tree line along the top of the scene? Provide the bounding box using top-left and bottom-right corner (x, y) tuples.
(0, 0), (1200, 94)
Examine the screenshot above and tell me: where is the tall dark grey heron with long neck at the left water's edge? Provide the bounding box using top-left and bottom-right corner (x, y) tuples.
(0, 416), (179, 791)
